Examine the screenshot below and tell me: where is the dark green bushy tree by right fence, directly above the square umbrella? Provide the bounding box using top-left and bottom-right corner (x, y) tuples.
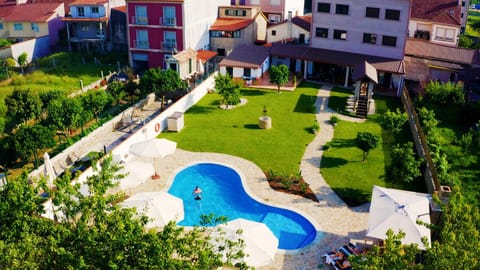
(391, 142), (422, 184)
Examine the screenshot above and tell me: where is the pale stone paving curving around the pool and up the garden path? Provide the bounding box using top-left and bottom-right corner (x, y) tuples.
(118, 84), (369, 270)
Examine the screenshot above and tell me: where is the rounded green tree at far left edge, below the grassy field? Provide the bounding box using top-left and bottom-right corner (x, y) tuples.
(5, 89), (42, 123)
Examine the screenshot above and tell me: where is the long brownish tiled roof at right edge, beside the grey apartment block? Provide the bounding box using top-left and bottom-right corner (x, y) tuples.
(405, 39), (480, 65)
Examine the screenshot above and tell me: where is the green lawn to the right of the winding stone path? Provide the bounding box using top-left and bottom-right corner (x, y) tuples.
(320, 93), (425, 206)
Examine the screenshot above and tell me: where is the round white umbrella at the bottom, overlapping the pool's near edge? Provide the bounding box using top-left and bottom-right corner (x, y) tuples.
(212, 218), (278, 267)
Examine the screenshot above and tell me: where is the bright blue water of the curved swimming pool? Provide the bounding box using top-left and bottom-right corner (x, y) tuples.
(168, 163), (317, 250)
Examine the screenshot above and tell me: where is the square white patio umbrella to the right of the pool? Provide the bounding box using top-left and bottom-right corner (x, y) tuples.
(367, 186), (430, 249)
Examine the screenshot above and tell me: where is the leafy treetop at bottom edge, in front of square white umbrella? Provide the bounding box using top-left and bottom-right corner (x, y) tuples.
(349, 229), (424, 270)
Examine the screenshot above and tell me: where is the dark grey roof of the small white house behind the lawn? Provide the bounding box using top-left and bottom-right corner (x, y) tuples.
(218, 45), (270, 68)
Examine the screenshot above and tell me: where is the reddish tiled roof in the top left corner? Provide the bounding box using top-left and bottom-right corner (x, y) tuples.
(2, 3), (63, 22)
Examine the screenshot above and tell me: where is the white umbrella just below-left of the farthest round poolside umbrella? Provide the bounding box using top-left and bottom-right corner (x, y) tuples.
(119, 159), (154, 189)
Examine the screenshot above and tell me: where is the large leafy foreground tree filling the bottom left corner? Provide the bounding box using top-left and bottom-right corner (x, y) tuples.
(0, 156), (246, 270)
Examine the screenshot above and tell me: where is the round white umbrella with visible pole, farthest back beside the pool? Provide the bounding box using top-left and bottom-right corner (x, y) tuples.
(129, 138), (177, 178)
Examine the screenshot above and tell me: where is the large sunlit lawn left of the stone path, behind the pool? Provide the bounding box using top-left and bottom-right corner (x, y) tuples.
(160, 83), (318, 173)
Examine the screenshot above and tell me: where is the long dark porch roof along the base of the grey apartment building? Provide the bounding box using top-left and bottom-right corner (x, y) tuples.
(270, 43), (405, 74)
